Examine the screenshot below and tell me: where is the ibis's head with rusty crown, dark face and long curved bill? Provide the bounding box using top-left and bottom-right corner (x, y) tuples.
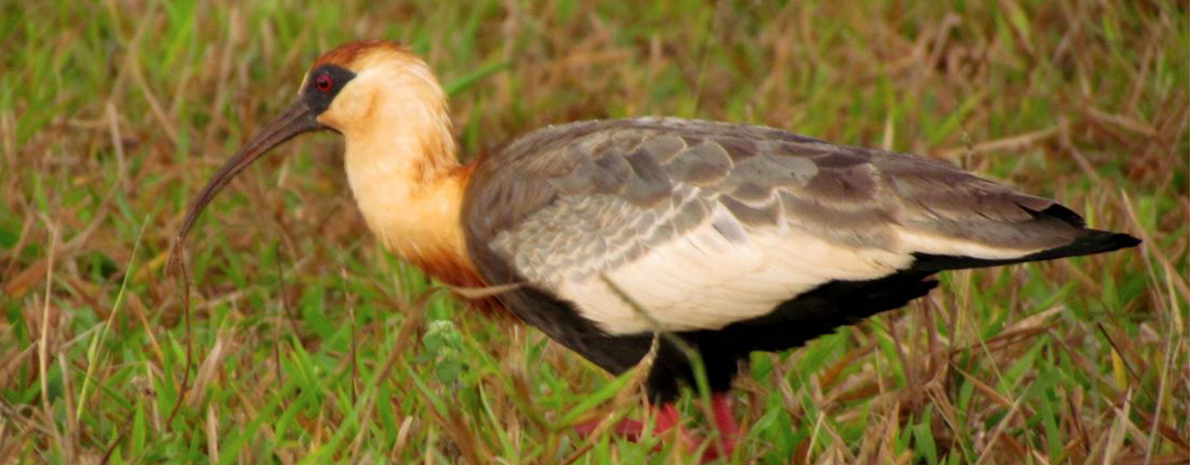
(167, 40), (453, 260)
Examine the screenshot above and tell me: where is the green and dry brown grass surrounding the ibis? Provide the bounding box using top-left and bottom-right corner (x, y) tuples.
(0, 0), (1190, 465)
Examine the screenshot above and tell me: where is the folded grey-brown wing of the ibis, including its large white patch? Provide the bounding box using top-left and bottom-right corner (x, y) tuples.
(465, 118), (1088, 334)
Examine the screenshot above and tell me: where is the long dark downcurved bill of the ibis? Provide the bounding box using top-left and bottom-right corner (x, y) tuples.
(174, 100), (324, 258)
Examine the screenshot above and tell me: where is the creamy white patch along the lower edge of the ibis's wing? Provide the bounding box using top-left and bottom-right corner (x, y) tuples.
(557, 206), (913, 334)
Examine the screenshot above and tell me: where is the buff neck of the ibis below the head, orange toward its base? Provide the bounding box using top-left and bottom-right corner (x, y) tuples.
(344, 90), (480, 285)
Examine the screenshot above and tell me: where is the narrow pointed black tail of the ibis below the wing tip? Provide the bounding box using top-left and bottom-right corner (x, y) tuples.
(913, 230), (1140, 272)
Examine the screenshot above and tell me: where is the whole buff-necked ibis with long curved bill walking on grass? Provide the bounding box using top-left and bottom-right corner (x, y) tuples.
(175, 40), (1140, 455)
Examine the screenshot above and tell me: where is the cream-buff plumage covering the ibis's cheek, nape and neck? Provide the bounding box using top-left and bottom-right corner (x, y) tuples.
(319, 49), (468, 269)
